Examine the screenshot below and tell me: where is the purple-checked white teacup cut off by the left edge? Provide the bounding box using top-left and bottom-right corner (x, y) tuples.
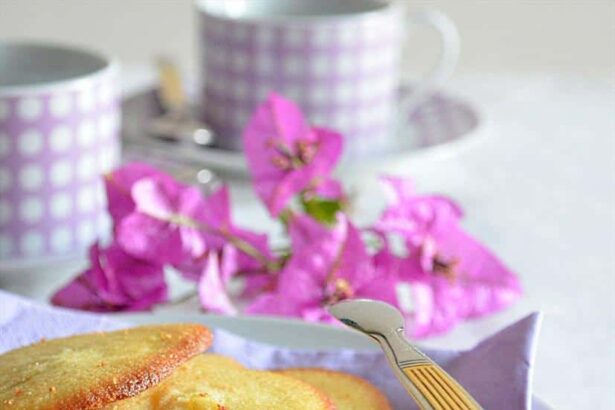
(0, 42), (120, 271)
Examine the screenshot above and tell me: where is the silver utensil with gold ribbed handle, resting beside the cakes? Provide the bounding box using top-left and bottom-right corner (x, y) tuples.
(329, 299), (481, 410)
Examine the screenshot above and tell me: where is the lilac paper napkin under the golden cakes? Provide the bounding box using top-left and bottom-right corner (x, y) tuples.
(0, 290), (541, 410)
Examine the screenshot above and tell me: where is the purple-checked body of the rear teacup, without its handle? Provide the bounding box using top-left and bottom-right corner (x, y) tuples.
(201, 8), (402, 156)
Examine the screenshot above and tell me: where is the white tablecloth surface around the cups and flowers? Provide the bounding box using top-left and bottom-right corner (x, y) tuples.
(0, 67), (615, 409)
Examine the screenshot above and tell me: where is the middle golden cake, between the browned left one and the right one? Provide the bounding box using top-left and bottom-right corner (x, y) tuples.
(107, 355), (335, 410)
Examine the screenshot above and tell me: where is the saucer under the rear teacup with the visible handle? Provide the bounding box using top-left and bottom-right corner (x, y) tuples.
(123, 91), (483, 175)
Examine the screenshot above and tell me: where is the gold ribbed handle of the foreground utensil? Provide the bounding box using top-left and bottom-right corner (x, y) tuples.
(401, 362), (481, 410)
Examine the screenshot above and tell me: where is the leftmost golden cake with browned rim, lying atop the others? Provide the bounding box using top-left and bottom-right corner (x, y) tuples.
(0, 324), (212, 410)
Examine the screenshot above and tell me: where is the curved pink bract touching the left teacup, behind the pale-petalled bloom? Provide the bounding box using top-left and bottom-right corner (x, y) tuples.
(104, 162), (173, 226)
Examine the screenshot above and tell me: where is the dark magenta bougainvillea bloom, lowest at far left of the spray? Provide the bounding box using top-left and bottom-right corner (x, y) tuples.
(51, 243), (167, 312)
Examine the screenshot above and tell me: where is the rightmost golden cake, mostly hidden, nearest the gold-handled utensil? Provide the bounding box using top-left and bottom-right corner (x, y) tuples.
(278, 368), (391, 410)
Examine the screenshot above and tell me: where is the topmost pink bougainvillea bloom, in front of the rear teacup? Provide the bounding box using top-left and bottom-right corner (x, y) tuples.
(243, 93), (342, 216)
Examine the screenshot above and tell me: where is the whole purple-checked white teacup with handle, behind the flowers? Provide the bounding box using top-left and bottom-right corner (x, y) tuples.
(197, 0), (459, 158)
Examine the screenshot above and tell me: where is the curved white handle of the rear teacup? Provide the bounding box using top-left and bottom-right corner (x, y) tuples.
(399, 10), (460, 118)
